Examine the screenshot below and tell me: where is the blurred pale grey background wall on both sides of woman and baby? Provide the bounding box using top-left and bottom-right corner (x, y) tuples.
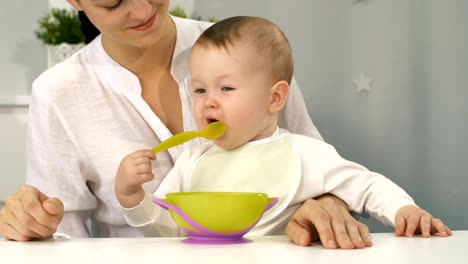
(0, 0), (468, 232)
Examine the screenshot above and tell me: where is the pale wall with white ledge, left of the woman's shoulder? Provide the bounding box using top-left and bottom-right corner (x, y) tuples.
(0, 0), (48, 199)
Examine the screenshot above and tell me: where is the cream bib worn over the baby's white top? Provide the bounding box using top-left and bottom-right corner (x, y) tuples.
(184, 134), (301, 225)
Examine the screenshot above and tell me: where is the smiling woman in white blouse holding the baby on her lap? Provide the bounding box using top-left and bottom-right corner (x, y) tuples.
(0, 0), (371, 248)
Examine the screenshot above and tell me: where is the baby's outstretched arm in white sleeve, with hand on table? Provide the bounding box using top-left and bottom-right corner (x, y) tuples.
(324, 142), (451, 237)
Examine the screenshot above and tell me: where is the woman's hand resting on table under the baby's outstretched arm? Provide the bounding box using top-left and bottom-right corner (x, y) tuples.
(286, 194), (372, 249)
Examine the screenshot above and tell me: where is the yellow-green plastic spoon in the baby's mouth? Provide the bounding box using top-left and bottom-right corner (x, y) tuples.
(153, 121), (226, 154)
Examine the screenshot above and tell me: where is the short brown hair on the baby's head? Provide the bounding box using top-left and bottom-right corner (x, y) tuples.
(195, 16), (294, 84)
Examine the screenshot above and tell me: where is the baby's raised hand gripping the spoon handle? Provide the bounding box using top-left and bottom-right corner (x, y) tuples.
(115, 150), (156, 208)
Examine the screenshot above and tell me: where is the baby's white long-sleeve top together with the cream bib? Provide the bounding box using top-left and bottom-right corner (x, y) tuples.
(123, 130), (415, 236)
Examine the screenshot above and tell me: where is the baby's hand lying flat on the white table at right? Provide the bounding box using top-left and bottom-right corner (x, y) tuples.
(395, 205), (452, 237)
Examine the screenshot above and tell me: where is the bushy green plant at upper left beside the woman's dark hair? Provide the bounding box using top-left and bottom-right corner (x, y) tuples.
(34, 8), (85, 45)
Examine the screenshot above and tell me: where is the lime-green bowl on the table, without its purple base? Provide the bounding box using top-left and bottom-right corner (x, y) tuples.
(160, 192), (275, 234)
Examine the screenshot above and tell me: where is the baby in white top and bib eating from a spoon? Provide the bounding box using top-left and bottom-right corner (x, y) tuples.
(115, 17), (451, 245)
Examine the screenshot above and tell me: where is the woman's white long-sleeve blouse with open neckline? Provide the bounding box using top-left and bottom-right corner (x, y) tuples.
(26, 17), (321, 237)
